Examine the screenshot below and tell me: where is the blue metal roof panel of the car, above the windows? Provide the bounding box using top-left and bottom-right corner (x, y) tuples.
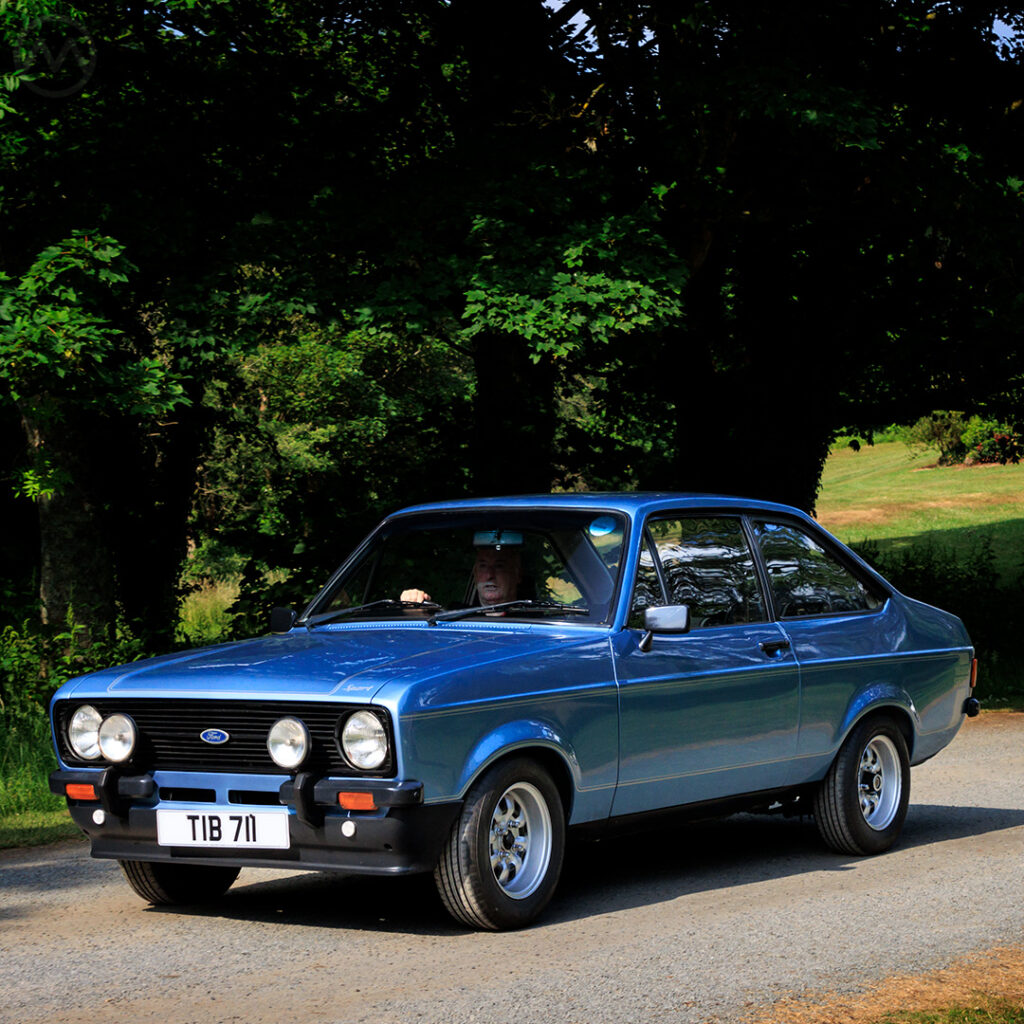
(395, 490), (808, 519)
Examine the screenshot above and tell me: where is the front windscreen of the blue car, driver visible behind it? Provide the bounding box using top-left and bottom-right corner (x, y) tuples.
(304, 509), (626, 626)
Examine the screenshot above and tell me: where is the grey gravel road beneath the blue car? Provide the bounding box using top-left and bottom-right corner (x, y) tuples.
(0, 714), (1024, 1024)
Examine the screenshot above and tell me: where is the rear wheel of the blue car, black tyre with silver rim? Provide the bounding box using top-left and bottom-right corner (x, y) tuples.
(814, 716), (910, 855)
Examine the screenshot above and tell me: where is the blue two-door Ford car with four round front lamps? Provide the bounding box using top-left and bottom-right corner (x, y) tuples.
(51, 494), (978, 930)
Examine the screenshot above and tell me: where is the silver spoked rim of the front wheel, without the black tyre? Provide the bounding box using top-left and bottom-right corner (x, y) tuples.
(488, 782), (552, 899)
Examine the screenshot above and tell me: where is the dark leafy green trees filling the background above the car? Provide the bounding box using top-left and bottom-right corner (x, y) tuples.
(0, 0), (1024, 637)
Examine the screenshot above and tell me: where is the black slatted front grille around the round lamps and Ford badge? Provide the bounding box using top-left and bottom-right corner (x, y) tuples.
(54, 697), (394, 777)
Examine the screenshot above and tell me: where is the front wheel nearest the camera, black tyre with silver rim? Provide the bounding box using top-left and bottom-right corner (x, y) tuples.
(434, 760), (565, 932)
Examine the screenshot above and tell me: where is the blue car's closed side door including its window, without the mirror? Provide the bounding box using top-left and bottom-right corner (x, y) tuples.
(612, 513), (800, 815)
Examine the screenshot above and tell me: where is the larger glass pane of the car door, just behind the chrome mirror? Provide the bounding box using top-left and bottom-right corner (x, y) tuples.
(649, 516), (765, 629)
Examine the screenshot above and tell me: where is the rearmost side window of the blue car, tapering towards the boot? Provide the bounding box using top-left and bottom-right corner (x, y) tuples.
(754, 521), (882, 618)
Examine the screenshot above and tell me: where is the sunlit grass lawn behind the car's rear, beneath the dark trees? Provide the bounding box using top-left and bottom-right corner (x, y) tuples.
(817, 441), (1024, 584)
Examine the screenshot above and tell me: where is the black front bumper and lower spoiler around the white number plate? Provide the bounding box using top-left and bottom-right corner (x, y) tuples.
(50, 767), (462, 874)
